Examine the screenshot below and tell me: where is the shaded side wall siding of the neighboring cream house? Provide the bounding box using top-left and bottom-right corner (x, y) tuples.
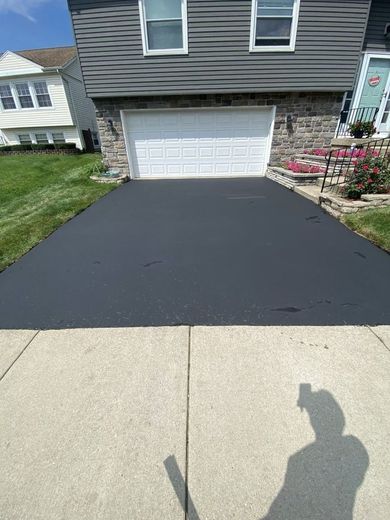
(63, 60), (97, 132)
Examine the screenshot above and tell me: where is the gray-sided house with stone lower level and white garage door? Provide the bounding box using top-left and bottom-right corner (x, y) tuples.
(68, 0), (390, 179)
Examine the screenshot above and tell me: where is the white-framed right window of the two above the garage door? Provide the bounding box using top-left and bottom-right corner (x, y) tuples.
(250, 0), (300, 52)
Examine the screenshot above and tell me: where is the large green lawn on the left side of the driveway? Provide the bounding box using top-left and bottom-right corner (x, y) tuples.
(0, 154), (116, 271)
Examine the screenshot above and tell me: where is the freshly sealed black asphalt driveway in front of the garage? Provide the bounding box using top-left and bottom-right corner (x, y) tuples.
(0, 179), (390, 329)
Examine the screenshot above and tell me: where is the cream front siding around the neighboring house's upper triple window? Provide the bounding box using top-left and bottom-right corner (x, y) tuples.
(0, 74), (74, 130)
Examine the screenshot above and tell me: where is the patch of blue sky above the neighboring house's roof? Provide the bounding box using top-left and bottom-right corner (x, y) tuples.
(0, 0), (74, 53)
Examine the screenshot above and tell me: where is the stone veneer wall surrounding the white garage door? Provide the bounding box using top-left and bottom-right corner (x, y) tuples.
(94, 92), (342, 173)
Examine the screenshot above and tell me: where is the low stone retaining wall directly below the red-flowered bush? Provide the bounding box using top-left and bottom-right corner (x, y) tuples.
(320, 193), (390, 219)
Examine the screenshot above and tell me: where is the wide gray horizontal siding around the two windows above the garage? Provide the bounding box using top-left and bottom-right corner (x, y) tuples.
(69, 0), (370, 98)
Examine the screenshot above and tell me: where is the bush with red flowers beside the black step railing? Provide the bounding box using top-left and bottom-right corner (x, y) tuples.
(343, 154), (390, 199)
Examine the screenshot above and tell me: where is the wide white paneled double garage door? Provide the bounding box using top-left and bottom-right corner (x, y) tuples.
(124, 108), (273, 179)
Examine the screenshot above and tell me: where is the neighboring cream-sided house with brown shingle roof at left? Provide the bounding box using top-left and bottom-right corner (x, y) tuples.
(0, 47), (99, 149)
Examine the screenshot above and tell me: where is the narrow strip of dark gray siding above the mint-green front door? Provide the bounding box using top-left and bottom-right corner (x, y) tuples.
(364, 0), (390, 52)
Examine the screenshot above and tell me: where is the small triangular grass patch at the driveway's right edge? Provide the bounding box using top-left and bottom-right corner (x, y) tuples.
(343, 207), (390, 252)
